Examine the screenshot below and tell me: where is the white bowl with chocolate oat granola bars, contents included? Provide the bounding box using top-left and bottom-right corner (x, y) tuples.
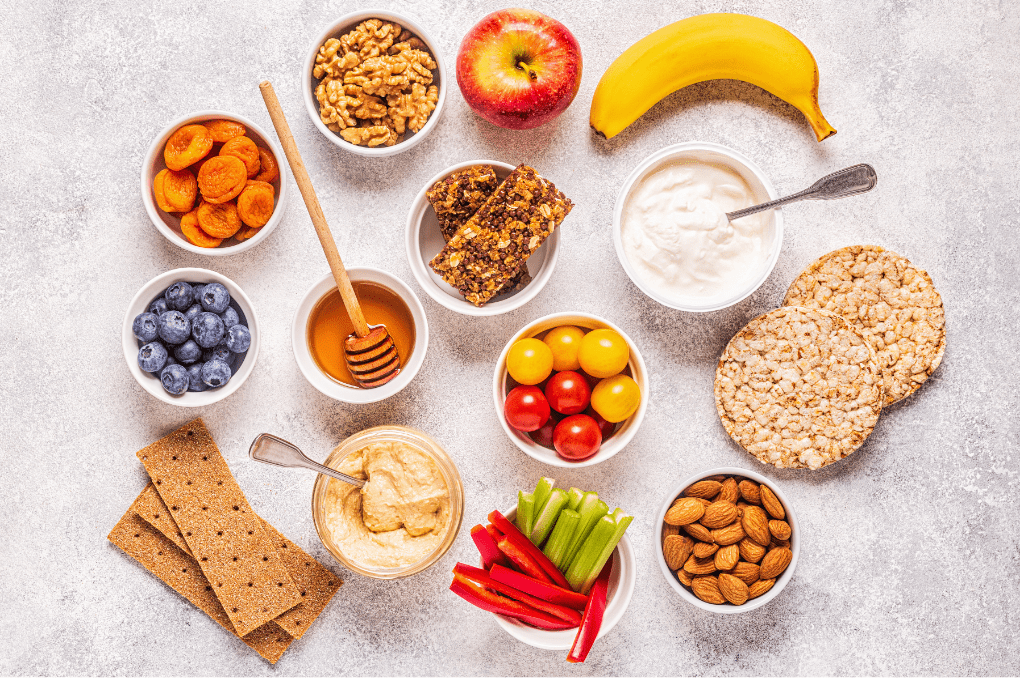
(405, 160), (573, 316)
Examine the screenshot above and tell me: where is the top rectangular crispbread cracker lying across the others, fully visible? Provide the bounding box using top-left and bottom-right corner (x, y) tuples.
(136, 418), (301, 635)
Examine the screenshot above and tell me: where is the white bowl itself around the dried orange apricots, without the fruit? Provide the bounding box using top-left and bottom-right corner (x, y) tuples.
(142, 109), (290, 257)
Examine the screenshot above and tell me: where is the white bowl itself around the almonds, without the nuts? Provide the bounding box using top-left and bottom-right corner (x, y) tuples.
(653, 468), (801, 614)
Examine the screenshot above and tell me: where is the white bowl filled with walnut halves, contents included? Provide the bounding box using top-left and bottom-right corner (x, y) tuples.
(302, 9), (446, 156)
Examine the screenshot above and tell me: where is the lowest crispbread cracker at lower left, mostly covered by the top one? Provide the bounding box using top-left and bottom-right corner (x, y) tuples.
(107, 510), (294, 664)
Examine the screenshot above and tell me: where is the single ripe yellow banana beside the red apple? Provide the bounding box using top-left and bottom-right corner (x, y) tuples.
(591, 14), (835, 142)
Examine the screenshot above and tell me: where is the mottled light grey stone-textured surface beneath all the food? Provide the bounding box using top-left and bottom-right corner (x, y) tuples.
(0, 0), (1020, 676)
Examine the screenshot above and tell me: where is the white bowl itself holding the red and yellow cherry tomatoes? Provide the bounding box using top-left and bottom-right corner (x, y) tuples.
(493, 312), (649, 468)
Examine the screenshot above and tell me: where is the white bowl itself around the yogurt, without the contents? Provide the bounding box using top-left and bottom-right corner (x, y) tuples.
(613, 142), (782, 312)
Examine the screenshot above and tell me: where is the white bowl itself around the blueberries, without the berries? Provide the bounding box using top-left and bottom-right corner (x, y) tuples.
(121, 267), (260, 407)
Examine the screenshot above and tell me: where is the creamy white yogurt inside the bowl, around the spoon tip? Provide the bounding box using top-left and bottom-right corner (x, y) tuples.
(620, 159), (773, 307)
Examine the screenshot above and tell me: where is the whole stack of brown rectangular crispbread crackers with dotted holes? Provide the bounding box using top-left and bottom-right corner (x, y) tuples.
(108, 419), (343, 664)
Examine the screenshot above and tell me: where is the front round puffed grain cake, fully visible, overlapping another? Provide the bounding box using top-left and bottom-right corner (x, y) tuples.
(715, 307), (882, 470)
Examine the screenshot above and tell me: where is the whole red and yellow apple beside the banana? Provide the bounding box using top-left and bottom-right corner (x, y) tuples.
(457, 9), (581, 129)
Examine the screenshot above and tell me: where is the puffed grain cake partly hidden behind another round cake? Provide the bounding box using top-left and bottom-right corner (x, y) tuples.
(784, 246), (946, 406)
